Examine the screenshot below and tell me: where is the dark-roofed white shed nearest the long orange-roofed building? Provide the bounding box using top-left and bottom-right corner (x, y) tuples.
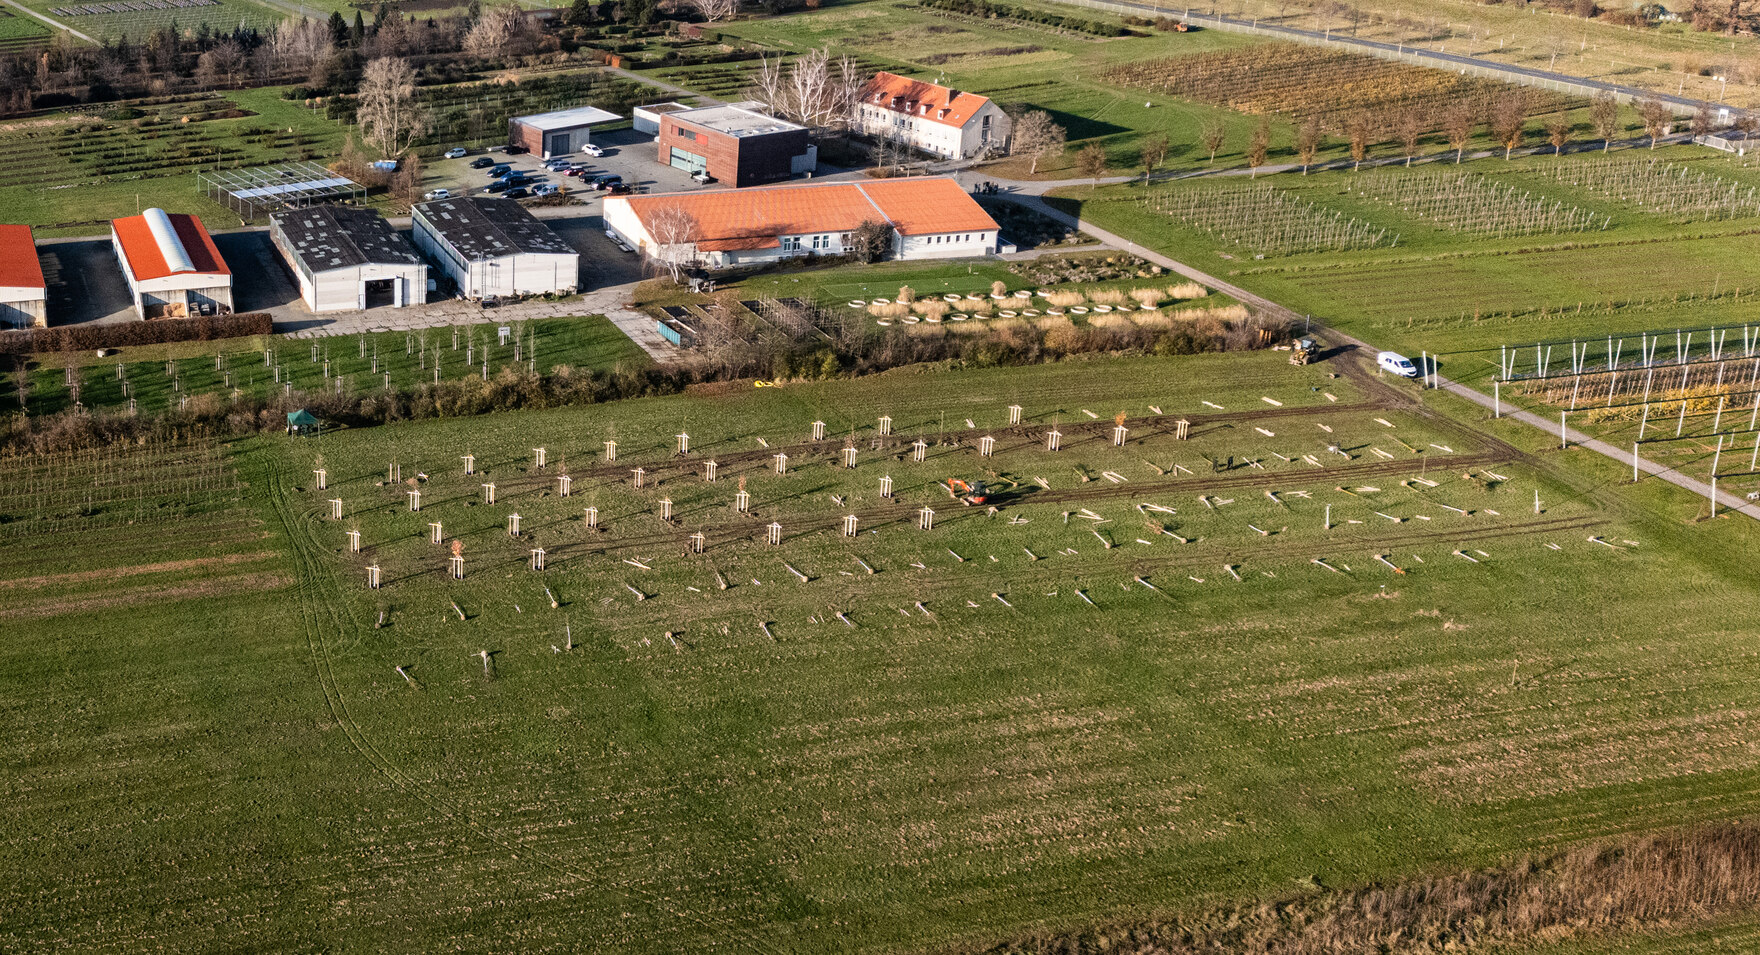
(410, 197), (581, 299)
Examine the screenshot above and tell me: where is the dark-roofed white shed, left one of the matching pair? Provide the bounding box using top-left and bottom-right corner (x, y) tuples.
(269, 206), (428, 311)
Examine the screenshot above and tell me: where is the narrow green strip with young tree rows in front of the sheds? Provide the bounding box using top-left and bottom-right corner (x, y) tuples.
(0, 317), (649, 415)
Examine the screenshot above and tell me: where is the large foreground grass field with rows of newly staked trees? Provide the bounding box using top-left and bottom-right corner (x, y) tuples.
(10, 354), (1756, 951)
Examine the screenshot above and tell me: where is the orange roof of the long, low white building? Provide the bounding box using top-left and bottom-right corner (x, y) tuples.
(607, 178), (996, 252)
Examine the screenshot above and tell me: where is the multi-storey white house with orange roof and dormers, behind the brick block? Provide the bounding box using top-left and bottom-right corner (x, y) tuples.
(855, 72), (1014, 158)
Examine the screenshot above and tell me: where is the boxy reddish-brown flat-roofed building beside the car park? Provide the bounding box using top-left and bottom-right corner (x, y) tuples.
(655, 106), (818, 188)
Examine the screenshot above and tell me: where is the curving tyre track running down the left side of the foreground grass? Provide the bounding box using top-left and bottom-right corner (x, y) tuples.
(259, 463), (783, 955)
